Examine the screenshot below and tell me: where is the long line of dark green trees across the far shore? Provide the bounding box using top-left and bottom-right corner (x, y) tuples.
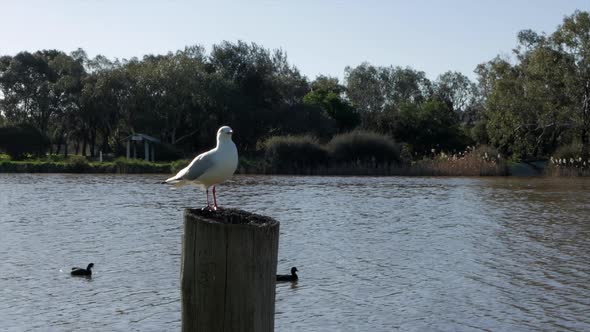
(0, 11), (590, 159)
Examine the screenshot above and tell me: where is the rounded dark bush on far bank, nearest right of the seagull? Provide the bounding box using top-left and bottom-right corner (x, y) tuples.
(263, 136), (327, 171)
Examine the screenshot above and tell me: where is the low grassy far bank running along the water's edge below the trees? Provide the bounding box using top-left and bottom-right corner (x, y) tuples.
(0, 156), (590, 177)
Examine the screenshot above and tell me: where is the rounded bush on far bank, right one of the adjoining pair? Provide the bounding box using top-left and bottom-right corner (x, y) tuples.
(327, 131), (401, 164)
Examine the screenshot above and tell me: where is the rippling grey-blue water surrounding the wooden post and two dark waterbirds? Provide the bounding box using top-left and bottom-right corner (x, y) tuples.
(0, 174), (590, 331)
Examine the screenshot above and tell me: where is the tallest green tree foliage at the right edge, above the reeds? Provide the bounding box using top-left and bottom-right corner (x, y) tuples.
(477, 11), (590, 159)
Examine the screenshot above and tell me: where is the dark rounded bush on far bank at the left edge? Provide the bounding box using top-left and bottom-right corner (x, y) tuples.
(0, 125), (49, 159)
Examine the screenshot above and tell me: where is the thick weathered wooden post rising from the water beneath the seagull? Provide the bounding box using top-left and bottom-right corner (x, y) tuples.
(180, 209), (279, 332)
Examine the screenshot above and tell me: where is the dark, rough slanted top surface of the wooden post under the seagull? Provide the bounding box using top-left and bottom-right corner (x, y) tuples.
(184, 208), (279, 227)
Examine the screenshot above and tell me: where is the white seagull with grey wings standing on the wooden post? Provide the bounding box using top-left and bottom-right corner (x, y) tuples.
(163, 126), (238, 210)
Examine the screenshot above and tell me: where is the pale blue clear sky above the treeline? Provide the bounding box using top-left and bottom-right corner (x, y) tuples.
(0, 0), (590, 80)
